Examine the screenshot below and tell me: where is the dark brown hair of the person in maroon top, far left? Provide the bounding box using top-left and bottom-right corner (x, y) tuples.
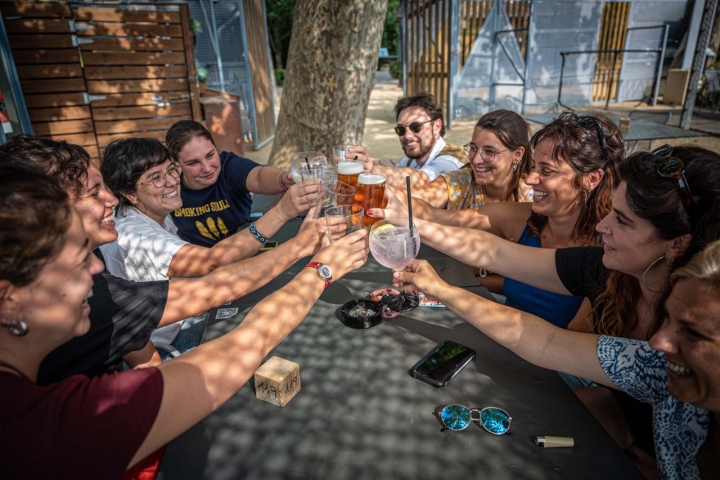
(0, 158), (72, 287)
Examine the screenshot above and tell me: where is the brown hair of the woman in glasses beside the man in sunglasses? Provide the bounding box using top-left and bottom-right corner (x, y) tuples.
(475, 110), (532, 202)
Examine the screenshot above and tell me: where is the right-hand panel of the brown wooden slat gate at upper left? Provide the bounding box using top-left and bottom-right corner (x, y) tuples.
(73, 4), (201, 154)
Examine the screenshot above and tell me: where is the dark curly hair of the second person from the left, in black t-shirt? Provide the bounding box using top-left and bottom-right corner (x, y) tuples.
(0, 134), (90, 198)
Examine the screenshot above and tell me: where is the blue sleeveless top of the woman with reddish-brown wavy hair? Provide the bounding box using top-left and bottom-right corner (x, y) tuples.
(503, 226), (583, 328)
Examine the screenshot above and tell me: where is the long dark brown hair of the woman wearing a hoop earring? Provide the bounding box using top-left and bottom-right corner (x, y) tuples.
(593, 146), (720, 337)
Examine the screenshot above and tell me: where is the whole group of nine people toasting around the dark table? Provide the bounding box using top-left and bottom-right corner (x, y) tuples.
(0, 94), (720, 479)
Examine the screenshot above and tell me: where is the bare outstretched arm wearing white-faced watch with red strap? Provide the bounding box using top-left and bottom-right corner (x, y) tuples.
(128, 230), (369, 466)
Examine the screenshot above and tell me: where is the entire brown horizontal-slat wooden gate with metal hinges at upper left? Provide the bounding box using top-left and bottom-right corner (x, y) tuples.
(0, 2), (201, 161)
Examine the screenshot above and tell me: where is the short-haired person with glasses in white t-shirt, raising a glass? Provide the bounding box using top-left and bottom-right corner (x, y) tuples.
(100, 138), (318, 358)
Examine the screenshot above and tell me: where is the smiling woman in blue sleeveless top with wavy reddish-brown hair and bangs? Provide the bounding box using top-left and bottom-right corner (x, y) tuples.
(376, 112), (625, 331)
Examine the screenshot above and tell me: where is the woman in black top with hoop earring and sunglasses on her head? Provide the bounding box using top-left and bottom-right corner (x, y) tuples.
(386, 146), (720, 476)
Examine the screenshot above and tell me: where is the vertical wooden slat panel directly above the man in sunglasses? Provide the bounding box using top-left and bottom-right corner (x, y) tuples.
(405, 0), (451, 118)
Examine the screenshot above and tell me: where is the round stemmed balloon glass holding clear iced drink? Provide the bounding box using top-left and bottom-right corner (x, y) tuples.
(370, 217), (420, 313)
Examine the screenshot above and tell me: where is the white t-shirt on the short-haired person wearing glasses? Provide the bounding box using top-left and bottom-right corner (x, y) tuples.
(100, 207), (188, 344)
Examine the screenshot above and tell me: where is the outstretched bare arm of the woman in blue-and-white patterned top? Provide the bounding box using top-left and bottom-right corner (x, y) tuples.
(393, 260), (615, 387)
